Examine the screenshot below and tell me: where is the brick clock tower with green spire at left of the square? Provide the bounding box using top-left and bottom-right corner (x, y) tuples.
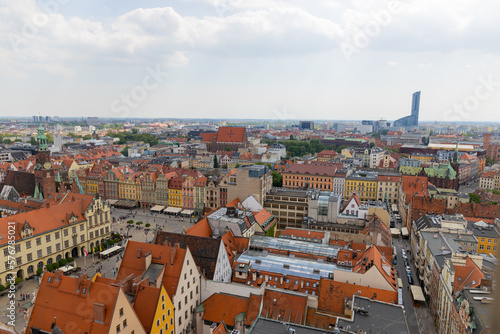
(35, 124), (56, 198)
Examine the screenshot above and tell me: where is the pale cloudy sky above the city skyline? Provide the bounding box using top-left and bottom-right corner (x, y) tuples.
(0, 0), (500, 123)
